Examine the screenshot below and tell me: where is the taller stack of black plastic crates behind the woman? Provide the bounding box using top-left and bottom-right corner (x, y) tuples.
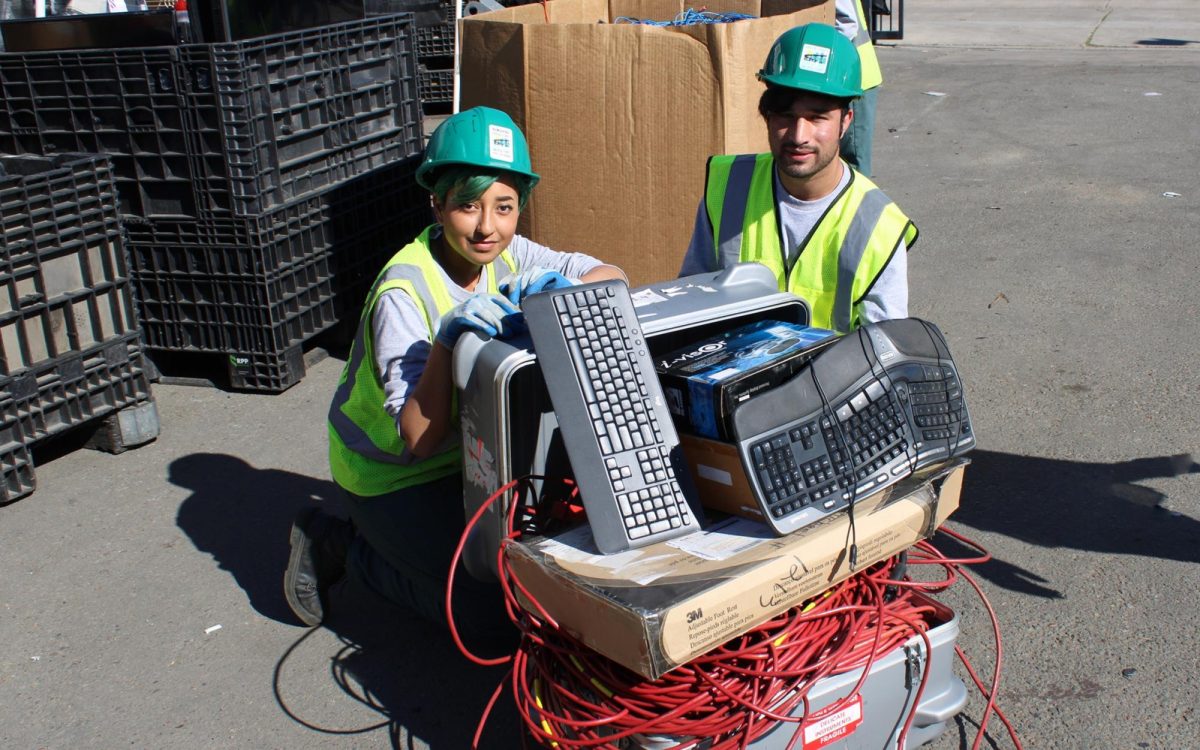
(0, 14), (428, 391)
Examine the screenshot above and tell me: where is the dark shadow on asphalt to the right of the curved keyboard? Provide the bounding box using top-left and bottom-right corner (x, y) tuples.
(938, 450), (1200, 598)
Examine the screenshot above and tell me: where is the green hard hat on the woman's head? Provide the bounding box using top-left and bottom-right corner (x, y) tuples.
(416, 107), (541, 191)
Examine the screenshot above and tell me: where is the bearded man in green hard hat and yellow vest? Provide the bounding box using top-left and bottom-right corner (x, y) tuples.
(679, 24), (917, 332)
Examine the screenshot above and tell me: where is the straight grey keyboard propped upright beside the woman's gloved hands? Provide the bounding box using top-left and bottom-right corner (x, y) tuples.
(521, 281), (700, 553)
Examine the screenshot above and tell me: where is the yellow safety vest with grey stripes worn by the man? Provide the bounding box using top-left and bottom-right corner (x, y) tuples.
(704, 154), (917, 332)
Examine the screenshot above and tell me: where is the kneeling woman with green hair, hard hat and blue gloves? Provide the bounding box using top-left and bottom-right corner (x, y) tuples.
(284, 107), (625, 632)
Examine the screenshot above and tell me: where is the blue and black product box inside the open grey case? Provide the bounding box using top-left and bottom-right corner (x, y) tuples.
(655, 320), (836, 440)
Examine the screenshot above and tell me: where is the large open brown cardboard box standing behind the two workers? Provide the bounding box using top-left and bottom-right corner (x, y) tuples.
(460, 0), (834, 286)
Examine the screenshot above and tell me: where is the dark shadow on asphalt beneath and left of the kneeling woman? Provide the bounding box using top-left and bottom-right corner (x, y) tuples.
(168, 454), (521, 750)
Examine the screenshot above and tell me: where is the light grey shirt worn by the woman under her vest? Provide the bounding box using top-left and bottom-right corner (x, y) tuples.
(371, 229), (602, 422)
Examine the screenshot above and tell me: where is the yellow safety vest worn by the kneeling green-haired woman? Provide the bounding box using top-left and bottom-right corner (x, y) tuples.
(329, 226), (517, 497)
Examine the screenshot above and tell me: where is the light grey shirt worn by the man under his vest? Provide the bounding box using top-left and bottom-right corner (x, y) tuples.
(679, 166), (908, 323)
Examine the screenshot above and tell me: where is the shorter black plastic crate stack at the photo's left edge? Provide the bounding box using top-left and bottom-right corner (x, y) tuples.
(0, 154), (158, 503)
